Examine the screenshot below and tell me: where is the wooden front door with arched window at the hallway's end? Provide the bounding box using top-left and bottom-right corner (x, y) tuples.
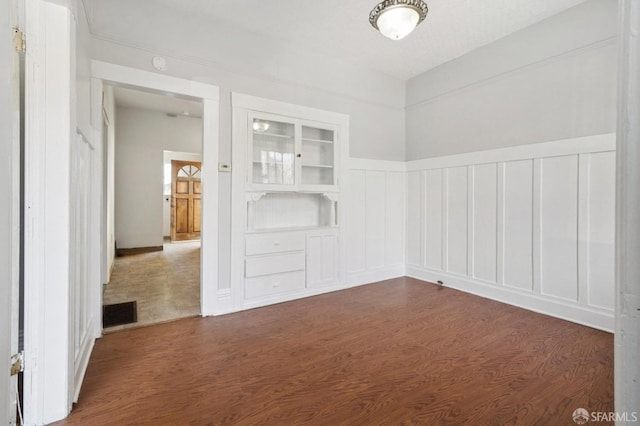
(171, 160), (202, 241)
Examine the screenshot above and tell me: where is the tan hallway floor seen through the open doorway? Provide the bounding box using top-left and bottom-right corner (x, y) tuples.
(103, 241), (200, 333)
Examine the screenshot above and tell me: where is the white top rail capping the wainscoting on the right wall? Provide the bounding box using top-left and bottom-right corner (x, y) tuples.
(407, 133), (616, 171)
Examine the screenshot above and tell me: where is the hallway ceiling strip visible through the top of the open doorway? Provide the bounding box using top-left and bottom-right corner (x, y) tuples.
(113, 87), (202, 118)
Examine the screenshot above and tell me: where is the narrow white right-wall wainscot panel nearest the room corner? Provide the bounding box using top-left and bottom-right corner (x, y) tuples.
(407, 172), (423, 265)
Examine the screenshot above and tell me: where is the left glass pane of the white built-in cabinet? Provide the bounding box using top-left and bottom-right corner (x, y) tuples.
(251, 118), (295, 185)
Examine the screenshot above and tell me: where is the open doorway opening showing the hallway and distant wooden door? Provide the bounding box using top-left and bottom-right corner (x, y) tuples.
(103, 85), (203, 332)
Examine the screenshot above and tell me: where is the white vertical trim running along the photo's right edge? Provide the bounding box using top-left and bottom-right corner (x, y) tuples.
(614, 0), (640, 414)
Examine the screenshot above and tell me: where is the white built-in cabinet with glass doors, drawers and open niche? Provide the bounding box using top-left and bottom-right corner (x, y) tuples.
(232, 94), (348, 309)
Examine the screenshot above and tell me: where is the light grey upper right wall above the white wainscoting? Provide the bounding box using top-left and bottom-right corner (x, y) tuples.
(406, 0), (617, 160)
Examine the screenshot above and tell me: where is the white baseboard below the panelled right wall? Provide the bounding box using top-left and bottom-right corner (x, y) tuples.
(407, 266), (614, 332)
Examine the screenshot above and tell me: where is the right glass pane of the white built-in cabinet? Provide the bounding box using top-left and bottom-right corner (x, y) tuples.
(301, 126), (335, 185)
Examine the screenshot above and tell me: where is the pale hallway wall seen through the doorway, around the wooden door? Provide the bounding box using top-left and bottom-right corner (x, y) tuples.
(115, 108), (200, 248)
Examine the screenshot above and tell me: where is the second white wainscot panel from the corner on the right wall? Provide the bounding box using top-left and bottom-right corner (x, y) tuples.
(424, 169), (443, 270)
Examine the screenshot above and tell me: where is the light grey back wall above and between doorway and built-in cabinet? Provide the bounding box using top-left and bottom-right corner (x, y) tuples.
(94, 30), (405, 288)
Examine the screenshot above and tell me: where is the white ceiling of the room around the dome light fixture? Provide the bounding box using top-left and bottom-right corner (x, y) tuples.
(84, 0), (585, 80)
